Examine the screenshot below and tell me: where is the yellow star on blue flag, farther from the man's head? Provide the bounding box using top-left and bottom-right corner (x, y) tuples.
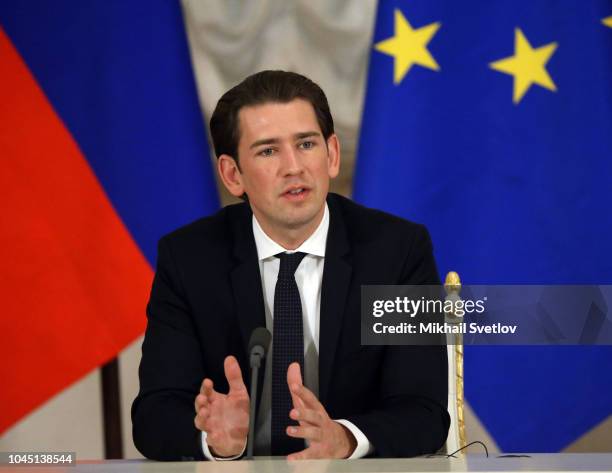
(489, 28), (558, 103)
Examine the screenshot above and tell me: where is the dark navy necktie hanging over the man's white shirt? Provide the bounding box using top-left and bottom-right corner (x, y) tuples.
(271, 253), (306, 455)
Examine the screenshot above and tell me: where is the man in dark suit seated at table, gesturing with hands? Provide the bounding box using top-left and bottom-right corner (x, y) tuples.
(132, 71), (449, 460)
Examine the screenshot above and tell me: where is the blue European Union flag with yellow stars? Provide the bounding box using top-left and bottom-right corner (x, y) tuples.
(354, 0), (612, 451)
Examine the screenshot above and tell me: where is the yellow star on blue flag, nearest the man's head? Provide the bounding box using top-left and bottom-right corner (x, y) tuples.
(374, 9), (440, 85)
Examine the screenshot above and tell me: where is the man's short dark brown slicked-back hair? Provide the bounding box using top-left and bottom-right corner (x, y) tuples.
(210, 71), (334, 162)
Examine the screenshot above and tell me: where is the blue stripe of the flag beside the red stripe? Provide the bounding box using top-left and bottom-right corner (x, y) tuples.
(0, 0), (218, 264)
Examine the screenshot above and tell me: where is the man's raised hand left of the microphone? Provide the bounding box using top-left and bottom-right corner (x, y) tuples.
(194, 356), (249, 457)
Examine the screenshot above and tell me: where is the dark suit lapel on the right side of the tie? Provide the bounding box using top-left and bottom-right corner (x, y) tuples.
(319, 195), (352, 405)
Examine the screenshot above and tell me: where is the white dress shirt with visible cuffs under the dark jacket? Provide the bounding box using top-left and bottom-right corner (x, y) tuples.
(202, 204), (373, 460)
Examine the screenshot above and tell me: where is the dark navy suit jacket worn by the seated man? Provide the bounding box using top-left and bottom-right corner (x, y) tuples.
(132, 194), (450, 460)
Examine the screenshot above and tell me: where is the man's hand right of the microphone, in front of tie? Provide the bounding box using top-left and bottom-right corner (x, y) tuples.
(287, 363), (357, 460)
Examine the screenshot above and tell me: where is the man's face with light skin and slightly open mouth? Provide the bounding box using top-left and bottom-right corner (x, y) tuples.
(220, 99), (340, 240)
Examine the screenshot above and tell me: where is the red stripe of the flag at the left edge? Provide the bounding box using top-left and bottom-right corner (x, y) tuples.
(0, 28), (152, 433)
